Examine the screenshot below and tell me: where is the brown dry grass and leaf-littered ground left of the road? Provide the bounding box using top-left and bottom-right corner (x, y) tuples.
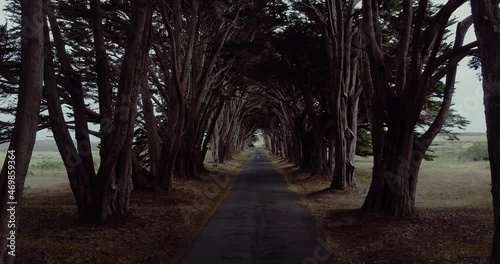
(17, 151), (251, 264)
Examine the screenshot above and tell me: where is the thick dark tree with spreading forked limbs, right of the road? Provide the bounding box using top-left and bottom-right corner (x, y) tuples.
(362, 0), (475, 217)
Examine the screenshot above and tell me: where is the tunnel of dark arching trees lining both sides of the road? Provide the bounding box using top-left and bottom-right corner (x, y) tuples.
(0, 0), (499, 262)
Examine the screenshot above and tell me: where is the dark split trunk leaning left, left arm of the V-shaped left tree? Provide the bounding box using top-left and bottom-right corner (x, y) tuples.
(44, 0), (105, 223)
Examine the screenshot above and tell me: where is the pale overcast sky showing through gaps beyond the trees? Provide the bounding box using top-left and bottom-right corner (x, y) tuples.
(0, 0), (486, 133)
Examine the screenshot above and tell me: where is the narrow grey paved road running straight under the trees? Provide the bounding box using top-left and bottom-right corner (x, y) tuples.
(179, 150), (332, 264)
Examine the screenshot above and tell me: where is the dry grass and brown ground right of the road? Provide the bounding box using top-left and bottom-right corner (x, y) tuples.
(273, 135), (493, 263)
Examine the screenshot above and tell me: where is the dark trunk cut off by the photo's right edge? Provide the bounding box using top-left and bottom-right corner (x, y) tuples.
(471, 0), (500, 264)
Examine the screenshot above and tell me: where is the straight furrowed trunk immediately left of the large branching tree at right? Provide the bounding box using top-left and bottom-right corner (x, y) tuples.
(316, 0), (361, 190)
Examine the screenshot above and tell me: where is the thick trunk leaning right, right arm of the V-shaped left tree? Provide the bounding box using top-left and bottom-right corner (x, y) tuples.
(93, 0), (152, 223)
